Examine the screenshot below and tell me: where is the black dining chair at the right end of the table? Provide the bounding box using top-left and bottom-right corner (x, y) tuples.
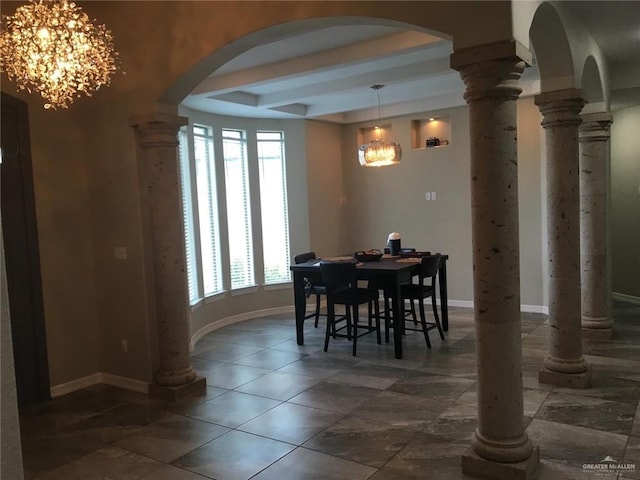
(400, 253), (444, 348)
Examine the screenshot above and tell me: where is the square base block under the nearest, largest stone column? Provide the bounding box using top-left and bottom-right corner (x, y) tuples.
(462, 446), (540, 480)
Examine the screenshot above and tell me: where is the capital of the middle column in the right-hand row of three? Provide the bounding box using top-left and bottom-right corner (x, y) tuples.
(535, 88), (586, 128)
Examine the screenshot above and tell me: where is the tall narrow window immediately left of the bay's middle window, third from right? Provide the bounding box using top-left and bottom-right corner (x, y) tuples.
(193, 125), (222, 296)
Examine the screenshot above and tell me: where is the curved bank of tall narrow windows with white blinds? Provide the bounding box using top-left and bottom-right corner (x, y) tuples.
(179, 124), (291, 305)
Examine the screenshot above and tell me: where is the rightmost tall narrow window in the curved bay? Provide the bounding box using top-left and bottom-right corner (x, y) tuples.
(256, 132), (291, 284)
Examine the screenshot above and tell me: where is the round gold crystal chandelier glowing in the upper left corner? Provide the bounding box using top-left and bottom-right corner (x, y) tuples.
(0, 0), (119, 109)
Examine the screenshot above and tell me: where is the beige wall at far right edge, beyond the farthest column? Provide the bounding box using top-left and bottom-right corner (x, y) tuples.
(611, 106), (640, 301)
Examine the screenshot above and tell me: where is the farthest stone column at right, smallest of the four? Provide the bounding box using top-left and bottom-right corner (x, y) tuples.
(580, 113), (613, 340)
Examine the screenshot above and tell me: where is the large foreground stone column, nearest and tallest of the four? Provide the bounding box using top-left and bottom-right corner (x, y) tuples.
(451, 42), (539, 479)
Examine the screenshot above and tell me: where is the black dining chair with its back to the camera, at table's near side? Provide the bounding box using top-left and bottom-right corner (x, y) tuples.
(320, 261), (382, 356)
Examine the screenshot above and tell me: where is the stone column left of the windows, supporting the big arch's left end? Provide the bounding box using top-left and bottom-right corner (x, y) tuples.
(130, 113), (206, 398)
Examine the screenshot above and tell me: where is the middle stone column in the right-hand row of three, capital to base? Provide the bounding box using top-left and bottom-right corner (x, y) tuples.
(535, 89), (591, 388)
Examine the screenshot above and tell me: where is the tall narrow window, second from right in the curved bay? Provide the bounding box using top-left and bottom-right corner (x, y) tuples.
(222, 129), (255, 289)
